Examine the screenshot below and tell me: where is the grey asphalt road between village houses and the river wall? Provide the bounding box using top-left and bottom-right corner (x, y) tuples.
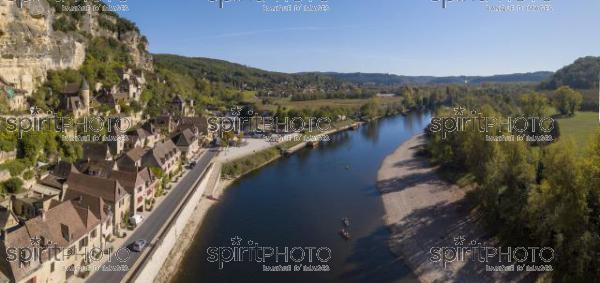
(87, 151), (217, 283)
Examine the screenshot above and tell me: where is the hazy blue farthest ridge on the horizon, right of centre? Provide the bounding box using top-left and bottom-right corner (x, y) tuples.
(314, 72), (553, 86)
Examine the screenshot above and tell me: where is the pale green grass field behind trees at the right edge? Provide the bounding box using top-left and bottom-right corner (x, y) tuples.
(558, 112), (600, 153)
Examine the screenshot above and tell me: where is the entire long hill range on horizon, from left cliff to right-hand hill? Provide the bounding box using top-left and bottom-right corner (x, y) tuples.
(154, 54), (553, 89)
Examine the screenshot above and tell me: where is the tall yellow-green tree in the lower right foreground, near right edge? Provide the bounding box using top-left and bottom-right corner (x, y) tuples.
(528, 140), (593, 282)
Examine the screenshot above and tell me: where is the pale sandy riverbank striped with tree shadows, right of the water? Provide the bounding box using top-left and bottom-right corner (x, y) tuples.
(377, 135), (523, 282)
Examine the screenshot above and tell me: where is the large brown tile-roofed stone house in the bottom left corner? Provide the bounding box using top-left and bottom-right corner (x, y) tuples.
(0, 201), (104, 282)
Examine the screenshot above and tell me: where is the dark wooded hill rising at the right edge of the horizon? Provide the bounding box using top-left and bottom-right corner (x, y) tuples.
(542, 56), (600, 89)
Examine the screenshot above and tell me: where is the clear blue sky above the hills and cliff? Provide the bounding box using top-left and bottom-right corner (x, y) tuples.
(113, 0), (600, 76)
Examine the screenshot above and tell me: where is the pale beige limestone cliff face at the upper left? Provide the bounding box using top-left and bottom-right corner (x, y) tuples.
(0, 0), (152, 94)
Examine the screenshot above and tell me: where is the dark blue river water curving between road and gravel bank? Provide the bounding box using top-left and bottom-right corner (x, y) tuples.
(174, 113), (431, 282)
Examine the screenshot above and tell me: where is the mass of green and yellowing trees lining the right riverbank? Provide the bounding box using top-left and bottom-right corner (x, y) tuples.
(427, 84), (600, 282)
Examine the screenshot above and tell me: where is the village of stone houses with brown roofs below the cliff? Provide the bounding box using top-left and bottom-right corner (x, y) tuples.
(0, 69), (217, 282)
